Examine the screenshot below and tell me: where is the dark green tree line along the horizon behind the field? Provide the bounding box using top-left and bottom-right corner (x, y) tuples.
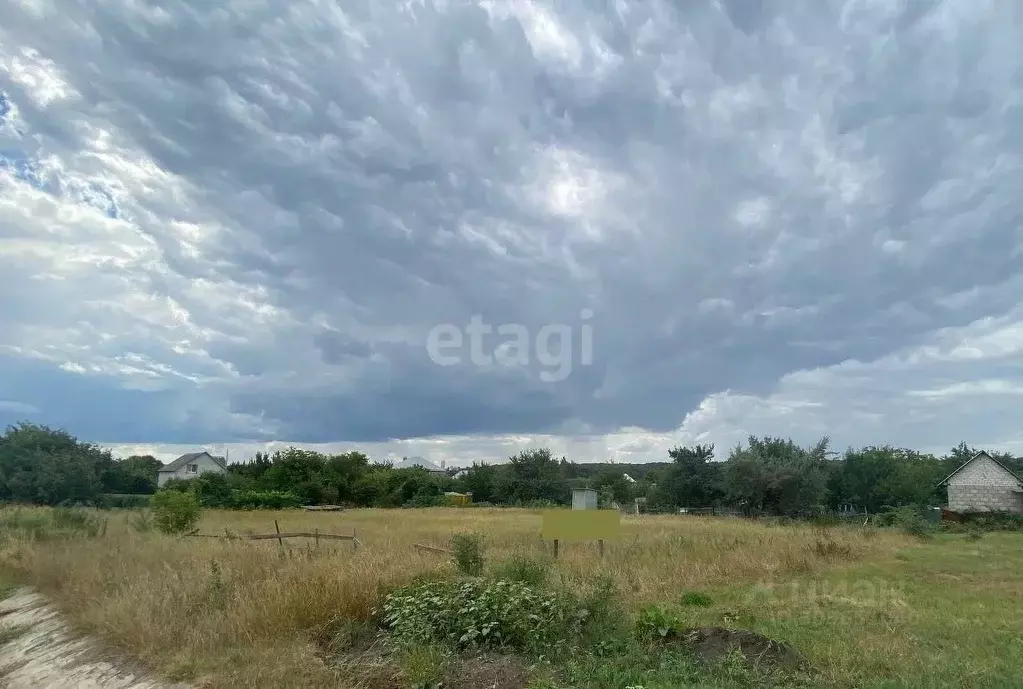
(0, 423), (1023, 515)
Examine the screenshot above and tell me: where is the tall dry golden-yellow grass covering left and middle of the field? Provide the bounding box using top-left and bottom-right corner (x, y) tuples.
(0, 508), (911, 687)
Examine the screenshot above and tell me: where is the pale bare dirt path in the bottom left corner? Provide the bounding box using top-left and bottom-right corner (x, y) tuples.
(0, 589), (189, 689)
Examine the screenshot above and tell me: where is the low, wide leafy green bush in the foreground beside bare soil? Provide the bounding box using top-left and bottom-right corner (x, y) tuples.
(381, 579), (588, 653)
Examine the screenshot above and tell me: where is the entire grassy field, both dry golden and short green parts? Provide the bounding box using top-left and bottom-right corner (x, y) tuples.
(0, 509), (1023, 689)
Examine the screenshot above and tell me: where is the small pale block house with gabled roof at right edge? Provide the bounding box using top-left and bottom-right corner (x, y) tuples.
(938, 452), (1023, 513)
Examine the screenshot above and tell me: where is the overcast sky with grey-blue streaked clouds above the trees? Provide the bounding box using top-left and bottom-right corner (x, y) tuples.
(0, 0), (1023, 464)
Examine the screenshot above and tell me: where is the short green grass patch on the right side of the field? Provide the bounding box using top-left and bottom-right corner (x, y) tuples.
(609, 534), (1023, 689)
